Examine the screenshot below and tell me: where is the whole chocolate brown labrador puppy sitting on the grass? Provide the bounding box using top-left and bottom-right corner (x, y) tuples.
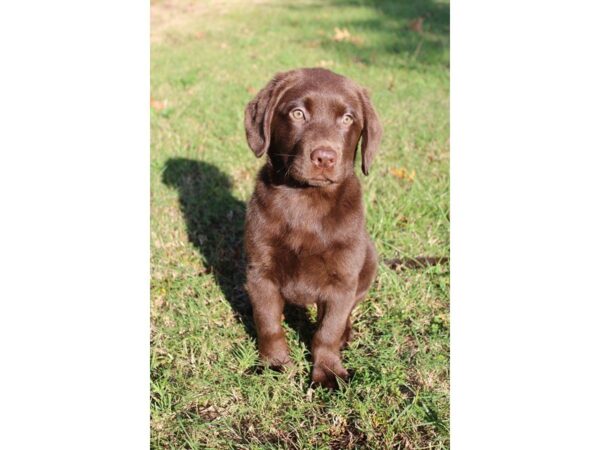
(245, 69), (382, 387)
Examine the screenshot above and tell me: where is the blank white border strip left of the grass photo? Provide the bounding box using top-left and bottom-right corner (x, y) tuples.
(0, 0), (150, 450)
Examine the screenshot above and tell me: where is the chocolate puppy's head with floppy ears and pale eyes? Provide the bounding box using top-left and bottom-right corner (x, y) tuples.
(245, 69), (382, 186)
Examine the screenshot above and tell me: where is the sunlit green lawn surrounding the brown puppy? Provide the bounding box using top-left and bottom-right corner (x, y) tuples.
(151, 0), (449, 449)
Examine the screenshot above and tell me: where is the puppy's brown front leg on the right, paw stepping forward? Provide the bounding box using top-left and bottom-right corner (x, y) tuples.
(312, 291), (354, 388)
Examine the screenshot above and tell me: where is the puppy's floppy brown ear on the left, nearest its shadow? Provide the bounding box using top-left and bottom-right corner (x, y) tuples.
(244, 72), (292, 158)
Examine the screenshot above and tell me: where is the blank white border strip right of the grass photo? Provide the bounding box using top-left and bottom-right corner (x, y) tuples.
(451, 0), (600, 450)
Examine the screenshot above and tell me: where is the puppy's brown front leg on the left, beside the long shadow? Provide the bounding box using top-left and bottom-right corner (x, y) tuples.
(246, 274), (291, 368)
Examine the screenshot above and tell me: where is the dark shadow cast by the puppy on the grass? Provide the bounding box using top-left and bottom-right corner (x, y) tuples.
(162, 158), (315, 356)
